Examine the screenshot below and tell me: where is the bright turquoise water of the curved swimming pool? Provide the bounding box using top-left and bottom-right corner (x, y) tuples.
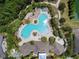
(21, 13), (48, 38)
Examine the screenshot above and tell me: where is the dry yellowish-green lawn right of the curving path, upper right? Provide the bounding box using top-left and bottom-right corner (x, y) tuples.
(61, 0), (79, 28)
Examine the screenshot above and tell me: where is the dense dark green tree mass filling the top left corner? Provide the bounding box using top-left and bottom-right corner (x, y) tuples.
(0, 0), (30, 26)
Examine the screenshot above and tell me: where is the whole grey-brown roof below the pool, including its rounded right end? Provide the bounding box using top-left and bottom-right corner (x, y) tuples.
(19, 41), (64, 56)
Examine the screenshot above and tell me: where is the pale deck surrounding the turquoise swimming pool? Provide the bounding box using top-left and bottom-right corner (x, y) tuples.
(18, 8), (53, 46)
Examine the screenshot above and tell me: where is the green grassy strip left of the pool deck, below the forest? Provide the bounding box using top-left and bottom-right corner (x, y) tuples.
(7, 19), (21, 54)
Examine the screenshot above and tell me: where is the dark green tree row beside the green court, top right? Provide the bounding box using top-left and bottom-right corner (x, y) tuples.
(68, 0), (75, 19)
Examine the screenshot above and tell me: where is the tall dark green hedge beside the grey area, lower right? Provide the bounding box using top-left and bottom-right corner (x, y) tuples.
(66, 33), (75, 56)
